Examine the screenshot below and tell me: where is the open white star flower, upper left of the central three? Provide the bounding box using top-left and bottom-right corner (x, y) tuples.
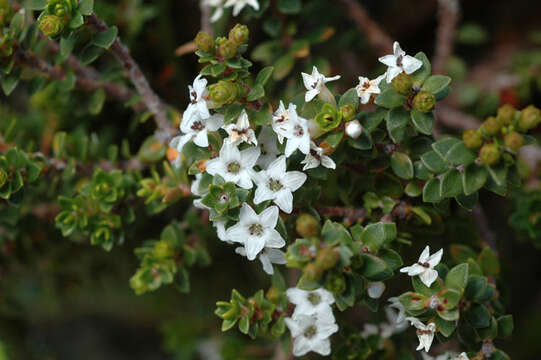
(206, 143), (260, 189)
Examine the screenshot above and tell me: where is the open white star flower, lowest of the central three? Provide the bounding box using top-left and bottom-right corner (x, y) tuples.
(226, 203), (286, 260)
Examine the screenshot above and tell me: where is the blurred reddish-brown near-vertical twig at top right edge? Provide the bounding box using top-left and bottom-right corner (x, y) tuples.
(432, 0), (460, 74)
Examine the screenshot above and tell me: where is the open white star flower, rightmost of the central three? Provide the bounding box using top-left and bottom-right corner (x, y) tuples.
(253, 155), (307, 214)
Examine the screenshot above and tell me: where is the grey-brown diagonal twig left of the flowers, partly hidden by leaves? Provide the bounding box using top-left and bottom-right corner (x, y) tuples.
(87, 14), (175, 143)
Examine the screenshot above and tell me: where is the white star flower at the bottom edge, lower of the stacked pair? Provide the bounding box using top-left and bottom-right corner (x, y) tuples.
(285, 315), (338, 356)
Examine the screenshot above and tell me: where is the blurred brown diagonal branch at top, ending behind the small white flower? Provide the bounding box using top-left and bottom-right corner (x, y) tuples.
(339, 0), (393, 56)
